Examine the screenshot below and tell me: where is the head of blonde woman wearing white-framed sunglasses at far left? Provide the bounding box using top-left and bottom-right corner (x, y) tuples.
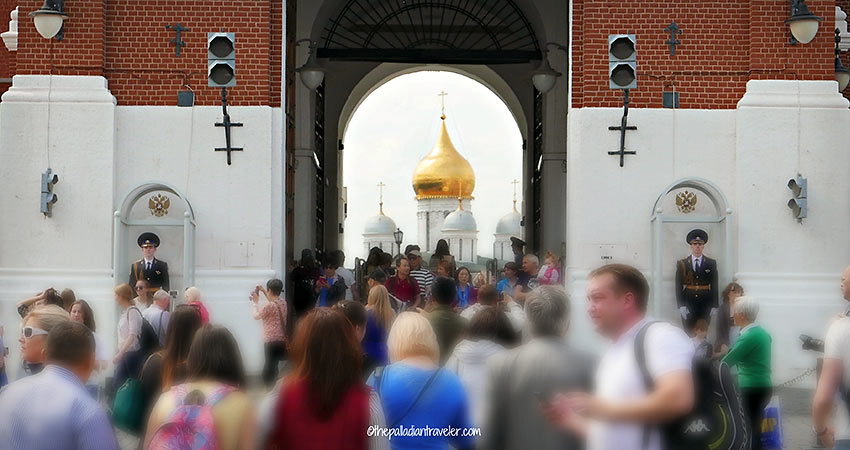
(18, 305), (71, 375)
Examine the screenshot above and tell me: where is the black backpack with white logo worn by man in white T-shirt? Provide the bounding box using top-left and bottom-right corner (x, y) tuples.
(635, 322), (751, 450)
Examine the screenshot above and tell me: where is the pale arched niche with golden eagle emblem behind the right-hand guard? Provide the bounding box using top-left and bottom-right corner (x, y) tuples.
(649, 178), (734, 324)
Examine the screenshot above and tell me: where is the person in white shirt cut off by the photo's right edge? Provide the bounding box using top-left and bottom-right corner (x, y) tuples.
(812, 266), (850, 450)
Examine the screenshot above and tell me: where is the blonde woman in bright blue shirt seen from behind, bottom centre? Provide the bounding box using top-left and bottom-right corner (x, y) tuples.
(368, 312), (478, 450)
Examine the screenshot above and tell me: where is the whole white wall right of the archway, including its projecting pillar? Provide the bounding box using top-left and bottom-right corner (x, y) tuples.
(566, 81), (850, 381)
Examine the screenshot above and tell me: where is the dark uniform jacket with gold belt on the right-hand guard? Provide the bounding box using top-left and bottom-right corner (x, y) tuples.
(676, 255), (718, 331)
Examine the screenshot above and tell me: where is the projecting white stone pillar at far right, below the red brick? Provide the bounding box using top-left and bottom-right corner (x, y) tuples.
(734, 80), (850, 381)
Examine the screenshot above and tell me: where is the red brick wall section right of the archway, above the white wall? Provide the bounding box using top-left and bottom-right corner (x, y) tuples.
(572, 0), (836, 109)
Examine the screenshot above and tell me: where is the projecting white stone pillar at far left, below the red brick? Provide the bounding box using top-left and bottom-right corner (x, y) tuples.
(0, 75), (116, 375)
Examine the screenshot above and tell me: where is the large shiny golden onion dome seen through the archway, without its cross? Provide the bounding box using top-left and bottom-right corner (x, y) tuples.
(413, 115), (475, 200)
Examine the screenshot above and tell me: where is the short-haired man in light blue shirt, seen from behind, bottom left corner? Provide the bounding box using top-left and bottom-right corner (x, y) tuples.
(0, 322), (118, 450)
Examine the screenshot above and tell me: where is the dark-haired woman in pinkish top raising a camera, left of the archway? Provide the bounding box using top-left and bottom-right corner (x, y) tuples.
(251, 278), (286, 388)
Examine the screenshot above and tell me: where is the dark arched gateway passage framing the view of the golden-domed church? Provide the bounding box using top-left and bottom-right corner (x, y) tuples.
(293, 0), (566, 264)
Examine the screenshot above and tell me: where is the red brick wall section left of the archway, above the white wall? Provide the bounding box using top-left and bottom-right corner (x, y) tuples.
(11, 0), (282, 106)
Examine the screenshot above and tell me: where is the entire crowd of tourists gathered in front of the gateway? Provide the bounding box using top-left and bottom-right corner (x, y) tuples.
(0, 243), (850, 450)
